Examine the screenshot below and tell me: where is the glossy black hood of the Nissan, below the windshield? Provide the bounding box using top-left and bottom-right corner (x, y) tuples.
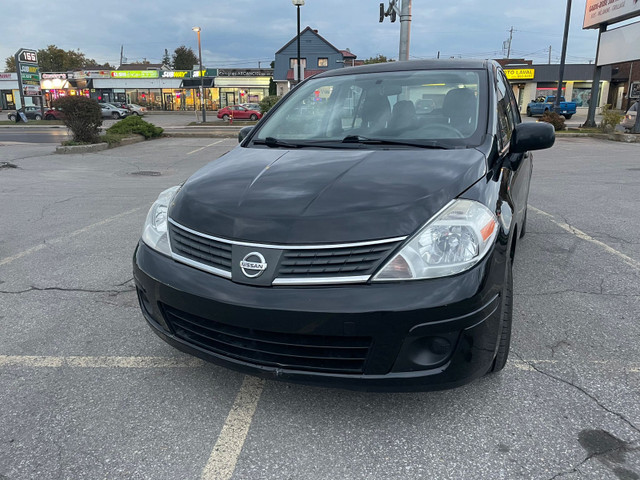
(169, 147), (486, 244)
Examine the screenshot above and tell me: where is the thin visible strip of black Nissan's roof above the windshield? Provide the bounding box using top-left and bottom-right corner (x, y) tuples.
(314, 58), (495, 78)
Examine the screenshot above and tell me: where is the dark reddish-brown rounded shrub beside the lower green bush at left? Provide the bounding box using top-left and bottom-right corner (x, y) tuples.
(52, 96), (102, 143)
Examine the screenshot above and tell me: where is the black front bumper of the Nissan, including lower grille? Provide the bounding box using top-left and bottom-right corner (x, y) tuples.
(133, 242), (505, 391)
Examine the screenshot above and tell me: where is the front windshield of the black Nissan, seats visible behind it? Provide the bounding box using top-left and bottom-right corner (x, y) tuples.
(252, 66), (488, 148)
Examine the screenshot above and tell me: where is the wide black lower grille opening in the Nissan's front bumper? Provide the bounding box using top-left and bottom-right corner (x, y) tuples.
(163, 305), (372, 374)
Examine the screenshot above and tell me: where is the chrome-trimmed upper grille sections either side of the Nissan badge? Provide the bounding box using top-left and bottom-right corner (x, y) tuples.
(169, 221), (404, 285)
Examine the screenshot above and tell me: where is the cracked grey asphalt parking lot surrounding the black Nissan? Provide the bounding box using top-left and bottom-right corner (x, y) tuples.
(0, 138), (640, 480)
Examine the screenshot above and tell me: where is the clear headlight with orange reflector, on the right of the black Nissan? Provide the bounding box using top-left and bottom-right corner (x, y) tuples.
(373, 200), (498, 281)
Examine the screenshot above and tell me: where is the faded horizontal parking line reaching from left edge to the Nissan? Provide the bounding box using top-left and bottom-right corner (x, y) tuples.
(0, 355), (205, 368)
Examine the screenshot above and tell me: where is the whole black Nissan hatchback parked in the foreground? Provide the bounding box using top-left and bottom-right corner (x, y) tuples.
(133, 60), (555, 390)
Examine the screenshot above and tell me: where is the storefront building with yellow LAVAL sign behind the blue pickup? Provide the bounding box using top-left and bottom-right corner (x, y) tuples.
(499, 60), (611, 113)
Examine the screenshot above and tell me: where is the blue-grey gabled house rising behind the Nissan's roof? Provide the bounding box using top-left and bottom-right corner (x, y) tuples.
(273, 27), (358, 95)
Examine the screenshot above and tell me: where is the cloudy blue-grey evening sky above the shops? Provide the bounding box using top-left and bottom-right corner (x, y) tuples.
(0, 0), (597, 71)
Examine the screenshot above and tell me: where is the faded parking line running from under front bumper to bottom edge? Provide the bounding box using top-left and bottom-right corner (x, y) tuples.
(200, 376), (265, 480)
